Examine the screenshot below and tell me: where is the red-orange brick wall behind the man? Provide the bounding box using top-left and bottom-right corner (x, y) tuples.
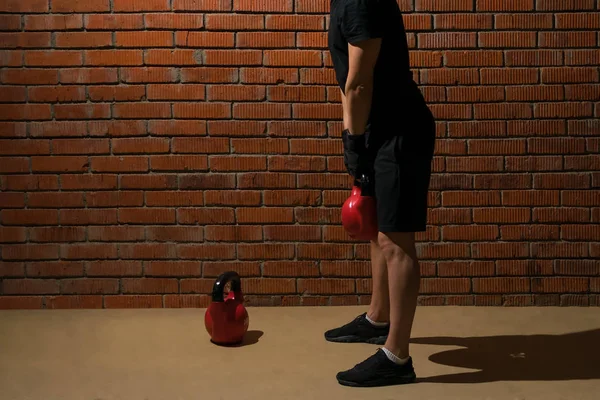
(0, 0), (600, 308)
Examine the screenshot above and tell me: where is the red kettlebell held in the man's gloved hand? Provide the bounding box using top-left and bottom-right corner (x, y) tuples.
(342, 174), (379, 241)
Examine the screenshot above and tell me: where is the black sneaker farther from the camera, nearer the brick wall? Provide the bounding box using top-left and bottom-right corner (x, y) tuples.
(325, 313), (390, 344)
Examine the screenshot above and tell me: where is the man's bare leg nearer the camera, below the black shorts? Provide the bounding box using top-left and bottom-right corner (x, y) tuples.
(379, 233), (421, 359)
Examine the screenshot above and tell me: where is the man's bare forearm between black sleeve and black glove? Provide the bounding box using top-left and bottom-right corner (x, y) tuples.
(342, 38), (381, 135)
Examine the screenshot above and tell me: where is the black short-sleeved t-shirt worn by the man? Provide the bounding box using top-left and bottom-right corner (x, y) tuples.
(328, 0), (426, 136)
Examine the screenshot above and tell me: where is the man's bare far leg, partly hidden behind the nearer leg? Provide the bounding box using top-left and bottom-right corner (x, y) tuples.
(367, 241), (390, 322)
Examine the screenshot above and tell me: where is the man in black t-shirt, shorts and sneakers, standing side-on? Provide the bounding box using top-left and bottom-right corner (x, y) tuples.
(325, 0), (435, 386)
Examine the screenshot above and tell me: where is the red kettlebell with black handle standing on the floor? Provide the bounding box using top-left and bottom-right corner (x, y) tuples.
(204, 271), (250, 345)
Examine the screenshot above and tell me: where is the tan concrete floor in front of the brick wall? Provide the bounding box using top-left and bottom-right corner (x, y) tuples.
(0, 307), (600, 400)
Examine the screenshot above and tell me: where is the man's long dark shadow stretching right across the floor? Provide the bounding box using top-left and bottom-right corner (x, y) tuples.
(411, 329), (600, 383)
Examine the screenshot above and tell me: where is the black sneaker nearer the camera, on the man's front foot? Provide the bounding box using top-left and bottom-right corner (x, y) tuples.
(336, 349), (417, 387)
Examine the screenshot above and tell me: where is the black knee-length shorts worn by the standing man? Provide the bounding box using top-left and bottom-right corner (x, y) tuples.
(373, 112), (435, 233)
